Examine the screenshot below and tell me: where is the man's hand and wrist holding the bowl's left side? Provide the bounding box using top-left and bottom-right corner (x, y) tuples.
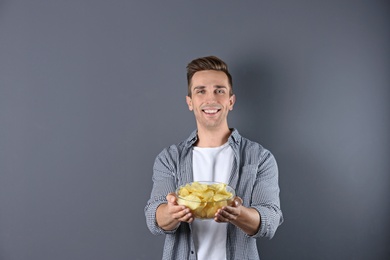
(156, 193), (194, 231)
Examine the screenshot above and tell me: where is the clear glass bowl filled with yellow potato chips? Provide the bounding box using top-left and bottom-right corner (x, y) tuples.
(176, 181), (235, 219)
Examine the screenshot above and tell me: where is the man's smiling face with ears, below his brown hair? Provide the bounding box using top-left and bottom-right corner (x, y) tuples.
(186, 70), (235, 130)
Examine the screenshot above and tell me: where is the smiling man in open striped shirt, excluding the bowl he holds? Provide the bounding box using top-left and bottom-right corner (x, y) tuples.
(145, 56), (283, 260)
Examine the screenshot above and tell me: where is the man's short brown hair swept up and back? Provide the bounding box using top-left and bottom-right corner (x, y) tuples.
(187, 56), (233, 97)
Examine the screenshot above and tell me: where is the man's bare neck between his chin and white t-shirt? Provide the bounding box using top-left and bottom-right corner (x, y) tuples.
(195, 127), (231, 147)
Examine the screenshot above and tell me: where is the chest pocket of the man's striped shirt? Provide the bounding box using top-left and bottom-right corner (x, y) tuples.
(236, 164), (257, 206)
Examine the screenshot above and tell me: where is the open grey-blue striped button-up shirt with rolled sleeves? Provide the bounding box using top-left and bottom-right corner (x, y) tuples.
(145, 129), (283, 260)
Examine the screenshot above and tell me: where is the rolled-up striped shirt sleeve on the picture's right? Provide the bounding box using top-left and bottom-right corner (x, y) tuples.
(251, 150), (283, 239)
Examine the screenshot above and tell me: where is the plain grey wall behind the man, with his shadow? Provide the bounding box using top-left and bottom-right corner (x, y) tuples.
(0, 0), (390, 260)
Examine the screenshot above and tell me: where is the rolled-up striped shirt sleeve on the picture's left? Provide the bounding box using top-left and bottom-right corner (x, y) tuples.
(145, 146), (176, 235)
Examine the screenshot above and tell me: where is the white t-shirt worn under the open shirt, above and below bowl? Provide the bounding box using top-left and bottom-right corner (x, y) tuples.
(192, 143), (234, 260)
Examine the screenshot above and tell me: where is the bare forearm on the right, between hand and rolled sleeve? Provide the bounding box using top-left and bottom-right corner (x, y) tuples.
(230, 206), (261, 236)
